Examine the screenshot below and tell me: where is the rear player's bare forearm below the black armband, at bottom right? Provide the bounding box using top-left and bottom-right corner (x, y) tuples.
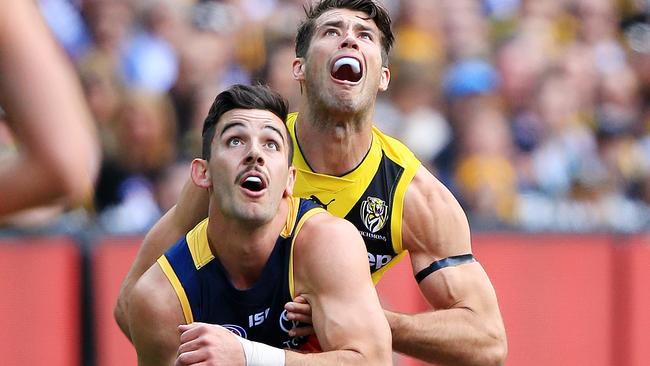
(385, 308), (506, 365)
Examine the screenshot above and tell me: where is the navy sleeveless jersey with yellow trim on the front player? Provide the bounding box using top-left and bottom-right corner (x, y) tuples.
(158, 198), (323, 348)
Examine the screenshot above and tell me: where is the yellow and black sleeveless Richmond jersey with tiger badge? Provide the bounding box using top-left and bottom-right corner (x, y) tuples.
(287, 113), (421, 284)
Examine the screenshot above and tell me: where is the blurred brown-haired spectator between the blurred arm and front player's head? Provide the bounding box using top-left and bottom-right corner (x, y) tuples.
(95, 91), (176, 233)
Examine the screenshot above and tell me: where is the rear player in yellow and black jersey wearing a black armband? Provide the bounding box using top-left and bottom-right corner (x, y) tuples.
(116, 0), (507, 365)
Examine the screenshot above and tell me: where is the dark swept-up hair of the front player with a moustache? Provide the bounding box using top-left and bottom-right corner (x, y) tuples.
(202, 84), (293, 165)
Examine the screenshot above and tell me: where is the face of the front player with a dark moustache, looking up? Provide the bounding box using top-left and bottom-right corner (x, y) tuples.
(208, 109), (295, 224)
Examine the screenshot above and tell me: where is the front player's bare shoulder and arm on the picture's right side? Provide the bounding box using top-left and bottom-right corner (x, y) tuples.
(286, 214), (392, 366)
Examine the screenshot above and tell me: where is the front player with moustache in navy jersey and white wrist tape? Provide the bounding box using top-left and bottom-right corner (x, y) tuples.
(128, 85), (392, 366)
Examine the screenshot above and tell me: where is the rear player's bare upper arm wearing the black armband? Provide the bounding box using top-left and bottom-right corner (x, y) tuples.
(403, 170), (496, 312)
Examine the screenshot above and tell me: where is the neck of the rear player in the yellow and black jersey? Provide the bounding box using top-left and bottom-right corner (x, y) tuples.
(296, 101), (372, 176)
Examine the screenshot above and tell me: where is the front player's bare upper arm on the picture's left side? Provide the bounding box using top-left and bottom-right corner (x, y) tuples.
(127, 264), (185, 366)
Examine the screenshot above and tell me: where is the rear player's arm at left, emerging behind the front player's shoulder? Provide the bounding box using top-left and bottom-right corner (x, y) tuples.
(114, 179), (208, 339)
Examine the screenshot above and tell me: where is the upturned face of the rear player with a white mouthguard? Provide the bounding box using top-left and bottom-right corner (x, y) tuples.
(294, 9), (390, 112)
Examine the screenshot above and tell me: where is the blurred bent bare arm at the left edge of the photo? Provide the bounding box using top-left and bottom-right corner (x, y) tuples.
(0, 0), (100, 217)
